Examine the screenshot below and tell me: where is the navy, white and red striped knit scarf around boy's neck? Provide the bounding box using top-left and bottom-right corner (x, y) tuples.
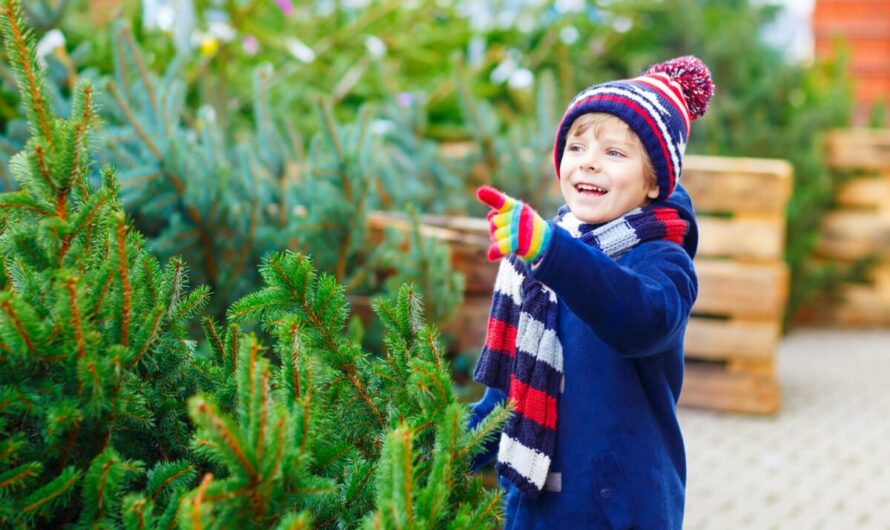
(473, 201), (689, 498)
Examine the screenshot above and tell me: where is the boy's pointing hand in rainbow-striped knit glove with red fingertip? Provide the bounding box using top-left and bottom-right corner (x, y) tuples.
(476, 186), (553, 263)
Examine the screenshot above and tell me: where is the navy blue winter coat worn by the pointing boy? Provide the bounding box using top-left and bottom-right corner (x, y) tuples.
(471, 186), (698, 530)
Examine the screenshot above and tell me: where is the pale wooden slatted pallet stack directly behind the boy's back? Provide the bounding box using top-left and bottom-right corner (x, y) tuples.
(680, 155), (792, 414)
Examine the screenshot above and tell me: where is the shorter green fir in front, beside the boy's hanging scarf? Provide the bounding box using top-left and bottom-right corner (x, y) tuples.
(179, 252), (509, 529)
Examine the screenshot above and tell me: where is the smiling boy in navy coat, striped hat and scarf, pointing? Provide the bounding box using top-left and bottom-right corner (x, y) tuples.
(471, 57), (713, 530)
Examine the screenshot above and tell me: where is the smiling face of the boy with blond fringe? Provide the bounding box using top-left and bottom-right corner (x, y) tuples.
(559, 124), (658, 224)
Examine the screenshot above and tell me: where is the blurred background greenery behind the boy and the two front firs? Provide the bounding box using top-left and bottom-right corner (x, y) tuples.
(0, 0), (851, 332)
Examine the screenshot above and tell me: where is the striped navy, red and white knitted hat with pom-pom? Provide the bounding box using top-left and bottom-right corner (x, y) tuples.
(553, 55), (714, 200)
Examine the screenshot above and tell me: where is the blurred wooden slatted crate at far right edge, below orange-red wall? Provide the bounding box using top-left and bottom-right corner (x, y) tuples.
(808, 129), (890, 326)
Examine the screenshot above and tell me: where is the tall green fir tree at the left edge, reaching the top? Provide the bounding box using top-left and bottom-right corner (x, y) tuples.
(0, 2), (209, 528)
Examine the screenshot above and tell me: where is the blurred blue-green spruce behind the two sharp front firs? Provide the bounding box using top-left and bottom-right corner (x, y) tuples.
(102, 28), (460, 328)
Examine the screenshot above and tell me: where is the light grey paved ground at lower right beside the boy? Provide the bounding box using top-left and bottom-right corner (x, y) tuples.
(680, 330), (890, 530)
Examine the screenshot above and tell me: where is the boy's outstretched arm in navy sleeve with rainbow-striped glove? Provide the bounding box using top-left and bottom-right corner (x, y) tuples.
(476, 186), (698, 357)
